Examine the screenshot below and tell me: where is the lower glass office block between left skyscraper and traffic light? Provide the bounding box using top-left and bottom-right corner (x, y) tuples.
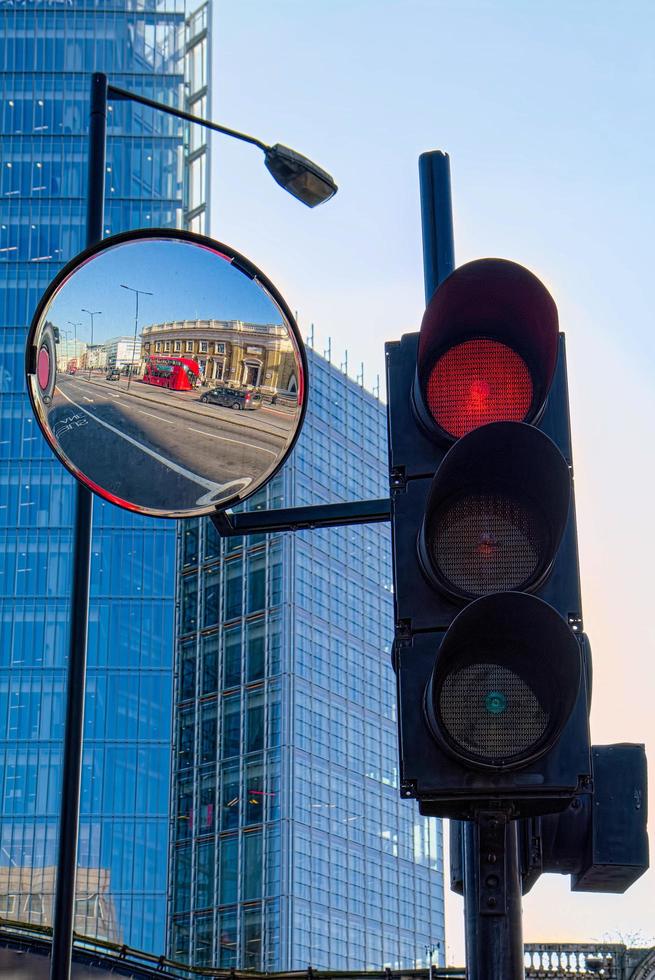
(169, 350), (444, 970)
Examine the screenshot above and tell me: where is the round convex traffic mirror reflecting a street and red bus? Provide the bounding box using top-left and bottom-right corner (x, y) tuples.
(27, 230), (307, 518)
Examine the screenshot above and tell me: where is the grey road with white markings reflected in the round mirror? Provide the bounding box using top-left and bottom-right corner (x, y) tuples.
(49, 374), (295, 508)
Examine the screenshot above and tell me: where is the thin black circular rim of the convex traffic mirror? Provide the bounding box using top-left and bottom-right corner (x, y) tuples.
(25, 228), (309, 520)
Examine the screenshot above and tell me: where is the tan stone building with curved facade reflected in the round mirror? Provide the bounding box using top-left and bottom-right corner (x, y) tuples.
(141, 320), (298, 396)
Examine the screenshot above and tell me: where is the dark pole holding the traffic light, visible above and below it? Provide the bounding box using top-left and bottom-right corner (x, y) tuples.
(419, 150), (525, 980)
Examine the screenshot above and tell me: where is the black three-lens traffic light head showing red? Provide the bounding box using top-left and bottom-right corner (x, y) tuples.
(386, 259), (591, 819)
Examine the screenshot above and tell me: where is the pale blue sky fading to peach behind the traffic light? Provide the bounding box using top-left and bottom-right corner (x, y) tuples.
(211, 0), (655, 964)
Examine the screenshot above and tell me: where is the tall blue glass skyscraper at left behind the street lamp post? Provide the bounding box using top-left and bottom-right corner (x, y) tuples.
(0, 0), (207, 952)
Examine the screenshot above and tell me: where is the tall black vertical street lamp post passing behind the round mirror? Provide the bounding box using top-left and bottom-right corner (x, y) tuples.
(50, 74), (107, 980)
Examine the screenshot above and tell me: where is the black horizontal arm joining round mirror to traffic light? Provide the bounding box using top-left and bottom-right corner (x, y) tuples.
(210, 498), (391, 538)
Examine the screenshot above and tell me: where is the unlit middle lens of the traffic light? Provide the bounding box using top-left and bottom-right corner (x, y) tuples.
(426, 493), (548, 596)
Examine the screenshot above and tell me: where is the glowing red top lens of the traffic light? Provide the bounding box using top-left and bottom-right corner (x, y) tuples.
(426, 337), (534, 438)
